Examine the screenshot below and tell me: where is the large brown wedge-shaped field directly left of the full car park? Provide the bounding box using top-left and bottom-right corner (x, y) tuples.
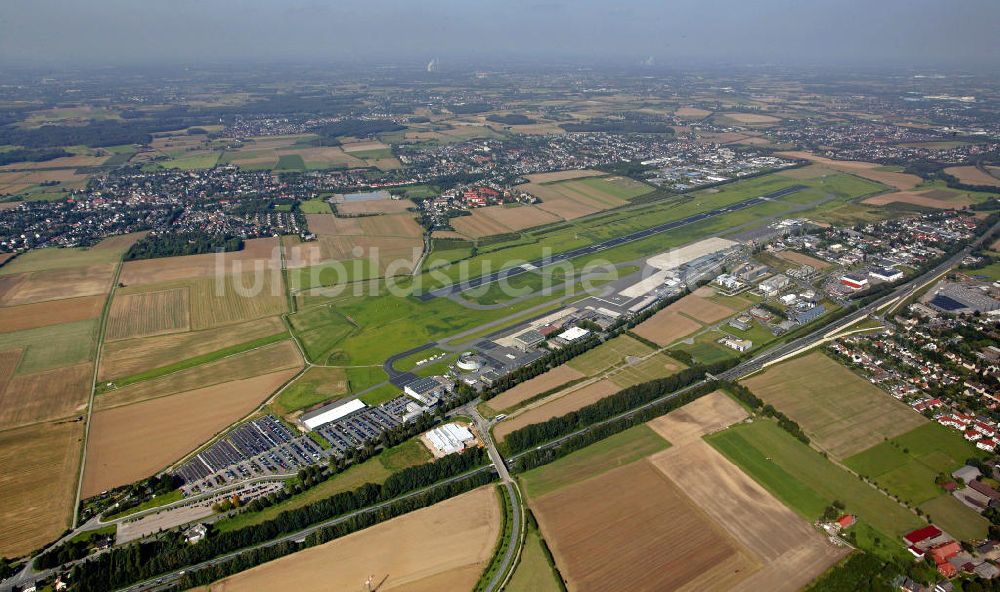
(83, 370), (296, 497)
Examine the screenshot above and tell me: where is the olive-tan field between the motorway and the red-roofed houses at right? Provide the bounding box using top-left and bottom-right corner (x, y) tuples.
(743, 352), (927, 458)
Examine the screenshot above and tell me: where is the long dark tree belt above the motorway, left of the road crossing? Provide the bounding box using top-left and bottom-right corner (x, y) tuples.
(72, 448), (488, 590)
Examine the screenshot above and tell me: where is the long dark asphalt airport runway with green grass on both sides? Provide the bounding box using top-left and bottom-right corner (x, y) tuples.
(418, 185), (808, 301)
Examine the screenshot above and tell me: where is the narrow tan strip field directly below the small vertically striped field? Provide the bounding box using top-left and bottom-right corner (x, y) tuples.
(98, 317), (285, 381)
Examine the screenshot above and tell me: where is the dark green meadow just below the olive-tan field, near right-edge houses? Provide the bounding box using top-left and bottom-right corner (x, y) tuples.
(844, 423), (983, 511)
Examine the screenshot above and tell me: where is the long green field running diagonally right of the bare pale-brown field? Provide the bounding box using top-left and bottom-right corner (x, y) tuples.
(706, 420), (924, 540)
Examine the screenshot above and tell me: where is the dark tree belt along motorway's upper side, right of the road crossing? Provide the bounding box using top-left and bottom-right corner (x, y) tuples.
(503, 360), (737, 453)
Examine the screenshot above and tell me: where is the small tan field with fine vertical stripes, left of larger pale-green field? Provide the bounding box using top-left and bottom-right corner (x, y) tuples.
(105, 287), (191, 340)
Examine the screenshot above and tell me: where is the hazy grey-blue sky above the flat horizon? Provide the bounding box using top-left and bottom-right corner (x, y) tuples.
(0, 0), (1000, 66)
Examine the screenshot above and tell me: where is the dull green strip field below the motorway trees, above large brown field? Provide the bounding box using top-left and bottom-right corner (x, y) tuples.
(520, 424), (670, 497)
